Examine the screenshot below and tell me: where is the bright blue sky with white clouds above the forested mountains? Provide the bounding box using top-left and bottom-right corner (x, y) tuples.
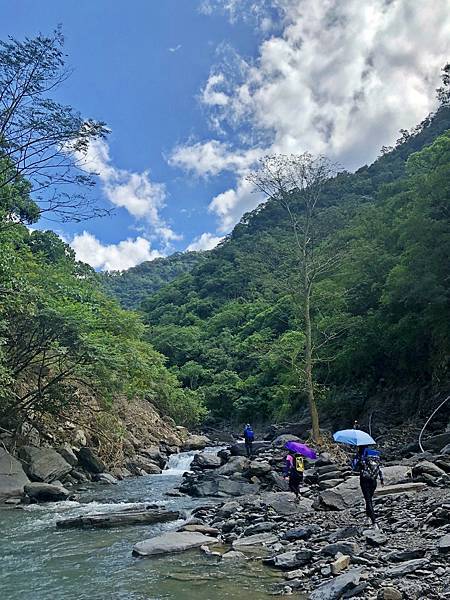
(0, 0), (450, 269)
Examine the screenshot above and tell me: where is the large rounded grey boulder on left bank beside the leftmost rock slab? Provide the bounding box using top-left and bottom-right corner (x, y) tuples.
(19, 446), (72, 483)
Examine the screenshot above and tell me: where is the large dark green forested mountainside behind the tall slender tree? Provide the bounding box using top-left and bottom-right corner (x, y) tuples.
(137, 103), (450, 423)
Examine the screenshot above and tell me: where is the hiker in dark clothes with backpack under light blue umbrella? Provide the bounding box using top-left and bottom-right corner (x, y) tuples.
(333, 429), (384, 529)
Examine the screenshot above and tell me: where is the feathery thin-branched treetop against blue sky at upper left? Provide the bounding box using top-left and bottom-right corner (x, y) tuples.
(0, 29), (108, 221)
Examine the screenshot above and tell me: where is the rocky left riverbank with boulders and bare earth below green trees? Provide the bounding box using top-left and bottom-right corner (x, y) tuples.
(0, 401), (209, 504)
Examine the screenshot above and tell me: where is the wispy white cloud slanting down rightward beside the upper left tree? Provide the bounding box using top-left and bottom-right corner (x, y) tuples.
(81, 140), (181, 243)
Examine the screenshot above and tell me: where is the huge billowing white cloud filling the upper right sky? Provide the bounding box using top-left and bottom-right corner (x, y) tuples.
(176, 0), (450, 231)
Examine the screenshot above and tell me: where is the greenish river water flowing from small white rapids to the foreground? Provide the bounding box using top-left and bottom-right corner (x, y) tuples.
(0, 453), (276, 600)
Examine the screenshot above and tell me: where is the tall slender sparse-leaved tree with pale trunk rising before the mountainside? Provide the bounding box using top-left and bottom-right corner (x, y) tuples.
(248, 152), (339, 442)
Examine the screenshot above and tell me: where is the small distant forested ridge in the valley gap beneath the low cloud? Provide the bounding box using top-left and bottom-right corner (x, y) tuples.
(97, 252), (204, 308)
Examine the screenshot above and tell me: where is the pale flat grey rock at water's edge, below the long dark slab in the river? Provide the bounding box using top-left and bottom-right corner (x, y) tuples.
(133, 531), (216, 556)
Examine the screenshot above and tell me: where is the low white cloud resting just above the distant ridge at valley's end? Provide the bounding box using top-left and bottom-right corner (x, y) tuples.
(70, 231), (162, 271)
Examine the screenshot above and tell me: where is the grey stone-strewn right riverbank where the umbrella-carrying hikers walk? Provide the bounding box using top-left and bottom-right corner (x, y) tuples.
(134, 436), (450, 600)
